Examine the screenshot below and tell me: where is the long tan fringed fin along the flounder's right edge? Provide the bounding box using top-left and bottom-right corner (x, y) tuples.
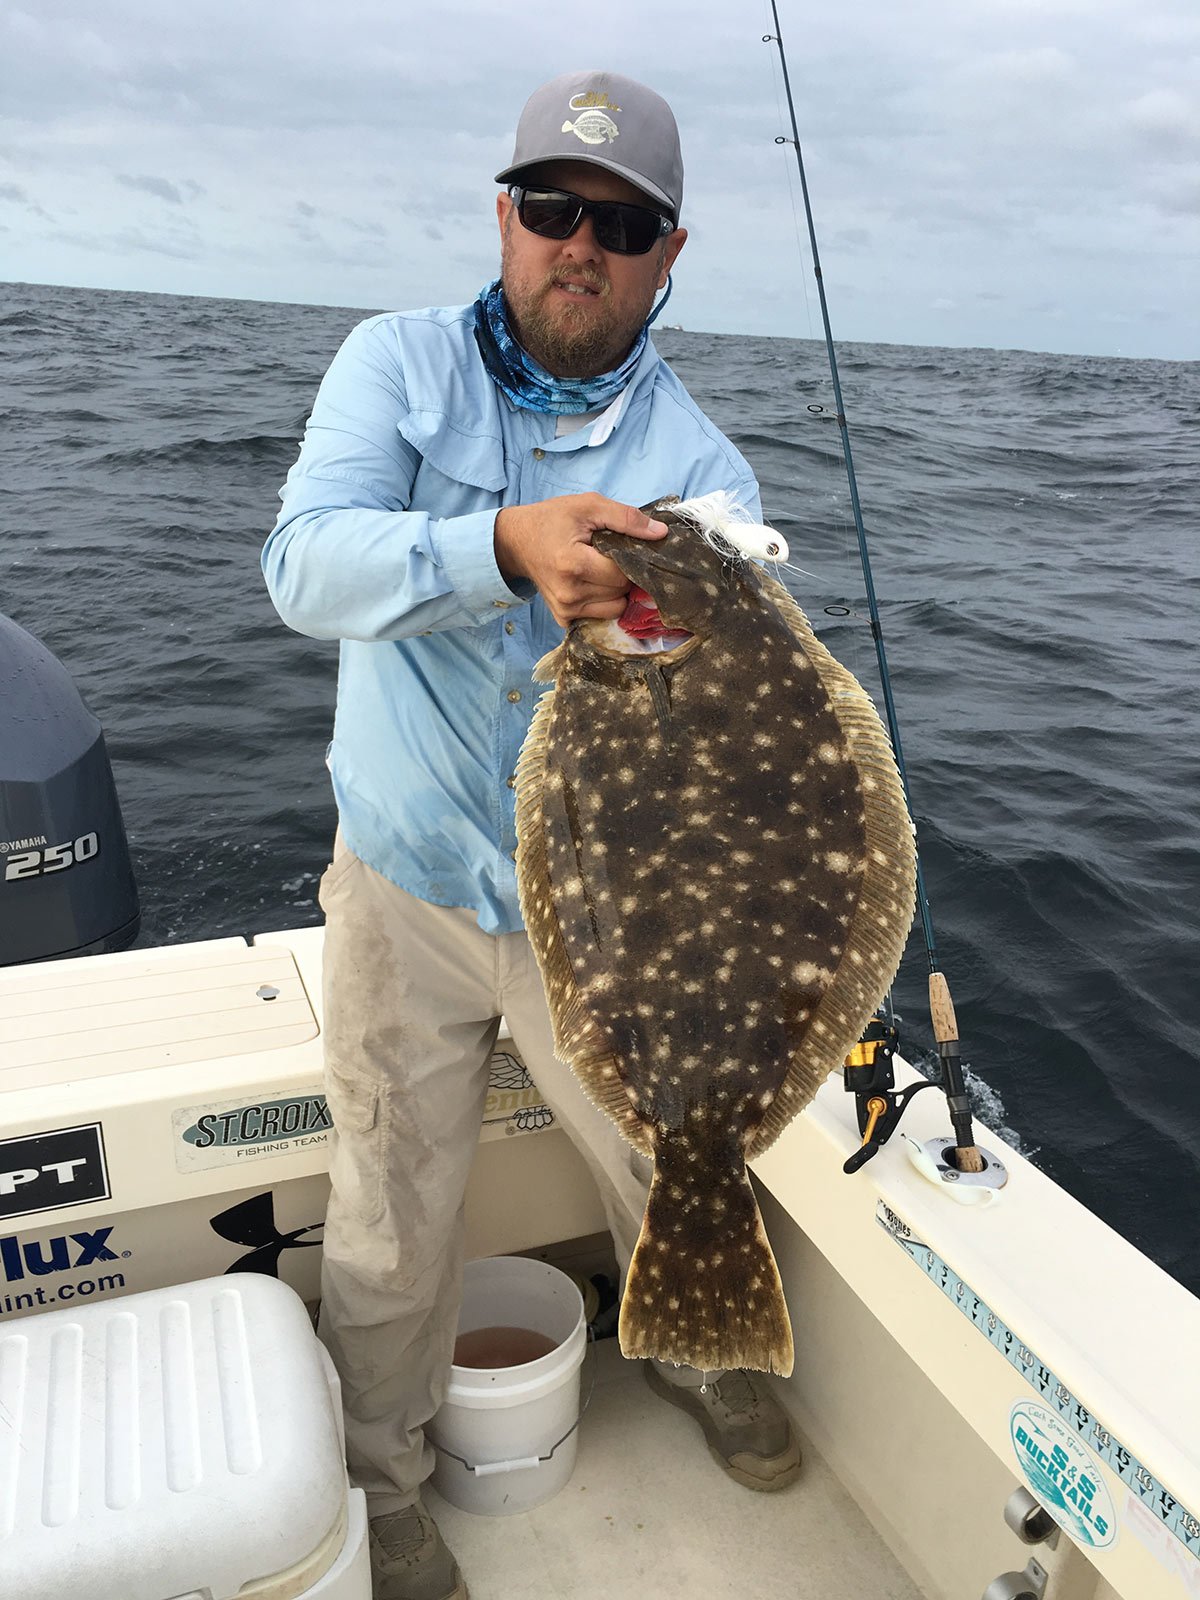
(746, 573), (917, 1160)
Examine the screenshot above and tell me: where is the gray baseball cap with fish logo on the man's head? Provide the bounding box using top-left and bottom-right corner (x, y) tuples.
(496, 72), (683, 222)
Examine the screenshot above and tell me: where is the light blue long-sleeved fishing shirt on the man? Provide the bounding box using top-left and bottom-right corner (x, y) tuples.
(262, 306), (760, 933)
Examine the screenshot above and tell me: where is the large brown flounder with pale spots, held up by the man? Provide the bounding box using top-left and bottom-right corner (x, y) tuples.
(517, 502), (915, 1373)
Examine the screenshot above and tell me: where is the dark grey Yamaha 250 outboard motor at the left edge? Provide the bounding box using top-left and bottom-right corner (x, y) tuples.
(0, 616), (141, 966)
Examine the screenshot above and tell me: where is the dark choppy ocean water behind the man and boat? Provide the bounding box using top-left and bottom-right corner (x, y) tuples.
(0, 285), (1200, 1293)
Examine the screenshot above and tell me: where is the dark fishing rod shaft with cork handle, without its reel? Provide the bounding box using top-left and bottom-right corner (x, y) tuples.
(763, 0), (984, 1173)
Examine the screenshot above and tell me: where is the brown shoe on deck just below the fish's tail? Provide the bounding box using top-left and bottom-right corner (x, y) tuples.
(643, 1362), (800, 1491)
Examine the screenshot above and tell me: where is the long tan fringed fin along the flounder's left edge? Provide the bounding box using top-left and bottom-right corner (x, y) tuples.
(517, 681), (651, 1155)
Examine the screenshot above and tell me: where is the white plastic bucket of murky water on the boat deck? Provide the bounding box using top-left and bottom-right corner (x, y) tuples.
(429, 1256), (587, 1517)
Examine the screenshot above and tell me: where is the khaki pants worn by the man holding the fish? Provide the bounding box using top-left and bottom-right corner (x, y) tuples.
(320, 837), (650, 1517)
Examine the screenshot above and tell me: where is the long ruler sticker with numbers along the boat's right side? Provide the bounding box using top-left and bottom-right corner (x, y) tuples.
(875, 1200), (1200, 1557)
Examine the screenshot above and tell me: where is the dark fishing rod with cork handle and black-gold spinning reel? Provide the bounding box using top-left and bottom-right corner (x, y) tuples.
(763, 0), (984, 1173)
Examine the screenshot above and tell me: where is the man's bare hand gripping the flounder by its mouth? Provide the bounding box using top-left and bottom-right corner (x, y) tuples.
(496, 494), (667, 627)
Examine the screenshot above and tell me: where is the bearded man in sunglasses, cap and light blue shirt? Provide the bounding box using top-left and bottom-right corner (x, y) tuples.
(262, 72), (800, 1600)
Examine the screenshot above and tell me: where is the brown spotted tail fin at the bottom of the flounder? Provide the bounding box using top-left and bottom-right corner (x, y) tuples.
(618, 1136), (794, 1378)
